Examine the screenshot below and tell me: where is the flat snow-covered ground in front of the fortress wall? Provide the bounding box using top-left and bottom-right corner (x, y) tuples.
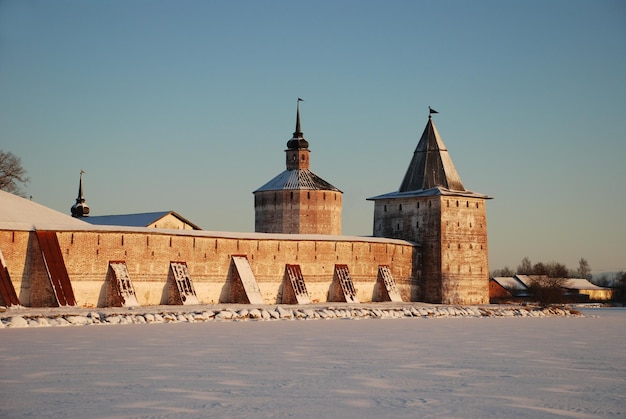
(0, 309), (626, 418)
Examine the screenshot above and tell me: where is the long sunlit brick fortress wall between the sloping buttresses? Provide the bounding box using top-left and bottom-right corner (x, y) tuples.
(0, 229), (419, 307)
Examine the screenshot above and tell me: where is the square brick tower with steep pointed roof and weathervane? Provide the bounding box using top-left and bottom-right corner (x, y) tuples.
(368, 110), (491, 304)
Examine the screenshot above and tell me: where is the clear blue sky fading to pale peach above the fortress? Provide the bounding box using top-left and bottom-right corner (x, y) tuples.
(0, 0), (626, 273)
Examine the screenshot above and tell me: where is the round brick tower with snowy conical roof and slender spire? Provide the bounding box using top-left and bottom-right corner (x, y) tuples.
(253, 99), (342, 235)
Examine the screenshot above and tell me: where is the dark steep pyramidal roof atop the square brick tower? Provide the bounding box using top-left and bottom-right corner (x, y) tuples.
(399, 117), (465, 192)
